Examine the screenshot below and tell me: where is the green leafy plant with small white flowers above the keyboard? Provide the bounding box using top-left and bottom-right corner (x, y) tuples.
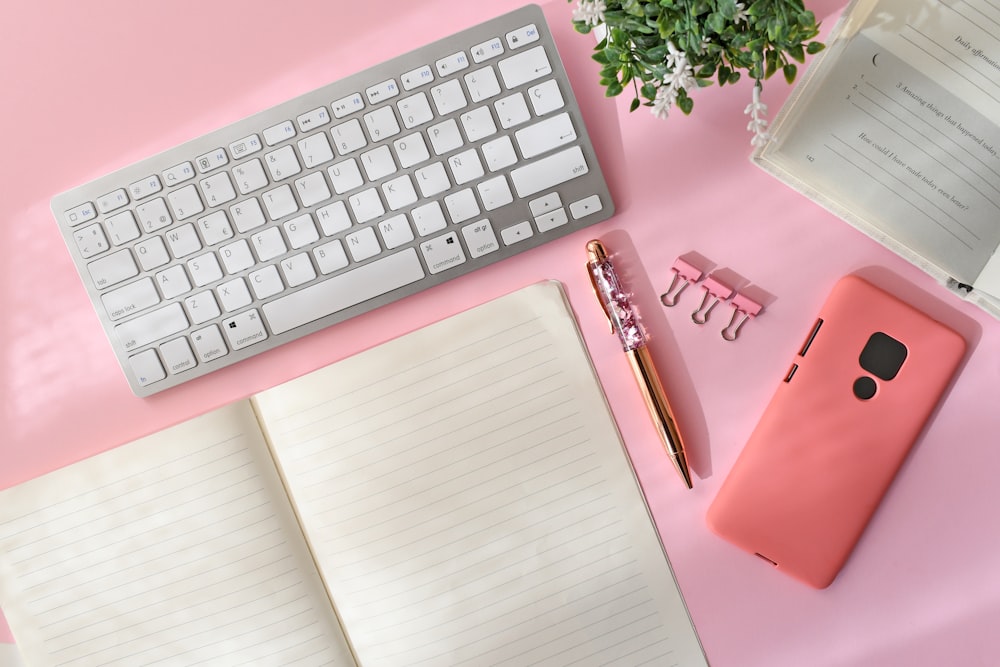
(569, 0), (824, 145)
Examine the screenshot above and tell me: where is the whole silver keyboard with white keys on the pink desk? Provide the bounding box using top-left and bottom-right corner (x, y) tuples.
(52, 5), (614, 396)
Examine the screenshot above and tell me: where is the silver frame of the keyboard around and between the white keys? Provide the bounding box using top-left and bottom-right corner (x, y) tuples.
(51, 5), (614, 396)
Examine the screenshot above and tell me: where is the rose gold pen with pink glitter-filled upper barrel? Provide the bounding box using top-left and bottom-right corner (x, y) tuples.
(587, 239), (692, 489)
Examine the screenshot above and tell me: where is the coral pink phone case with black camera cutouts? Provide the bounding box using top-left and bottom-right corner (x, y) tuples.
(707, 276), (965, 588)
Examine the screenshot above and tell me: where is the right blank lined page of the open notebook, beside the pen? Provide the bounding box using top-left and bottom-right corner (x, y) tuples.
(254, 283), (704, 667)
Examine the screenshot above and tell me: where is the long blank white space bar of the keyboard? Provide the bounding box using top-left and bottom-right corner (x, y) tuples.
(262, 248), (424, 334)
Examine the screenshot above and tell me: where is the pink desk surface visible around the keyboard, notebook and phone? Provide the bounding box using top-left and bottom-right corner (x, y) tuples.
(0, 0), (1000, 667)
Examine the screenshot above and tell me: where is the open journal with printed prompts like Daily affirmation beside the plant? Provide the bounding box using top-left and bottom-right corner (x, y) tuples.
(754, 0), (1000, 317)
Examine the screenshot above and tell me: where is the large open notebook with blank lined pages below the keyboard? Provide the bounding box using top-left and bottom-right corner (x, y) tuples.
(0, 282), (705, 667)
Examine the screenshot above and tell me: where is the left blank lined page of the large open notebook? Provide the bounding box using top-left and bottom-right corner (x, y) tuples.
(0, 402), (354, 666)
